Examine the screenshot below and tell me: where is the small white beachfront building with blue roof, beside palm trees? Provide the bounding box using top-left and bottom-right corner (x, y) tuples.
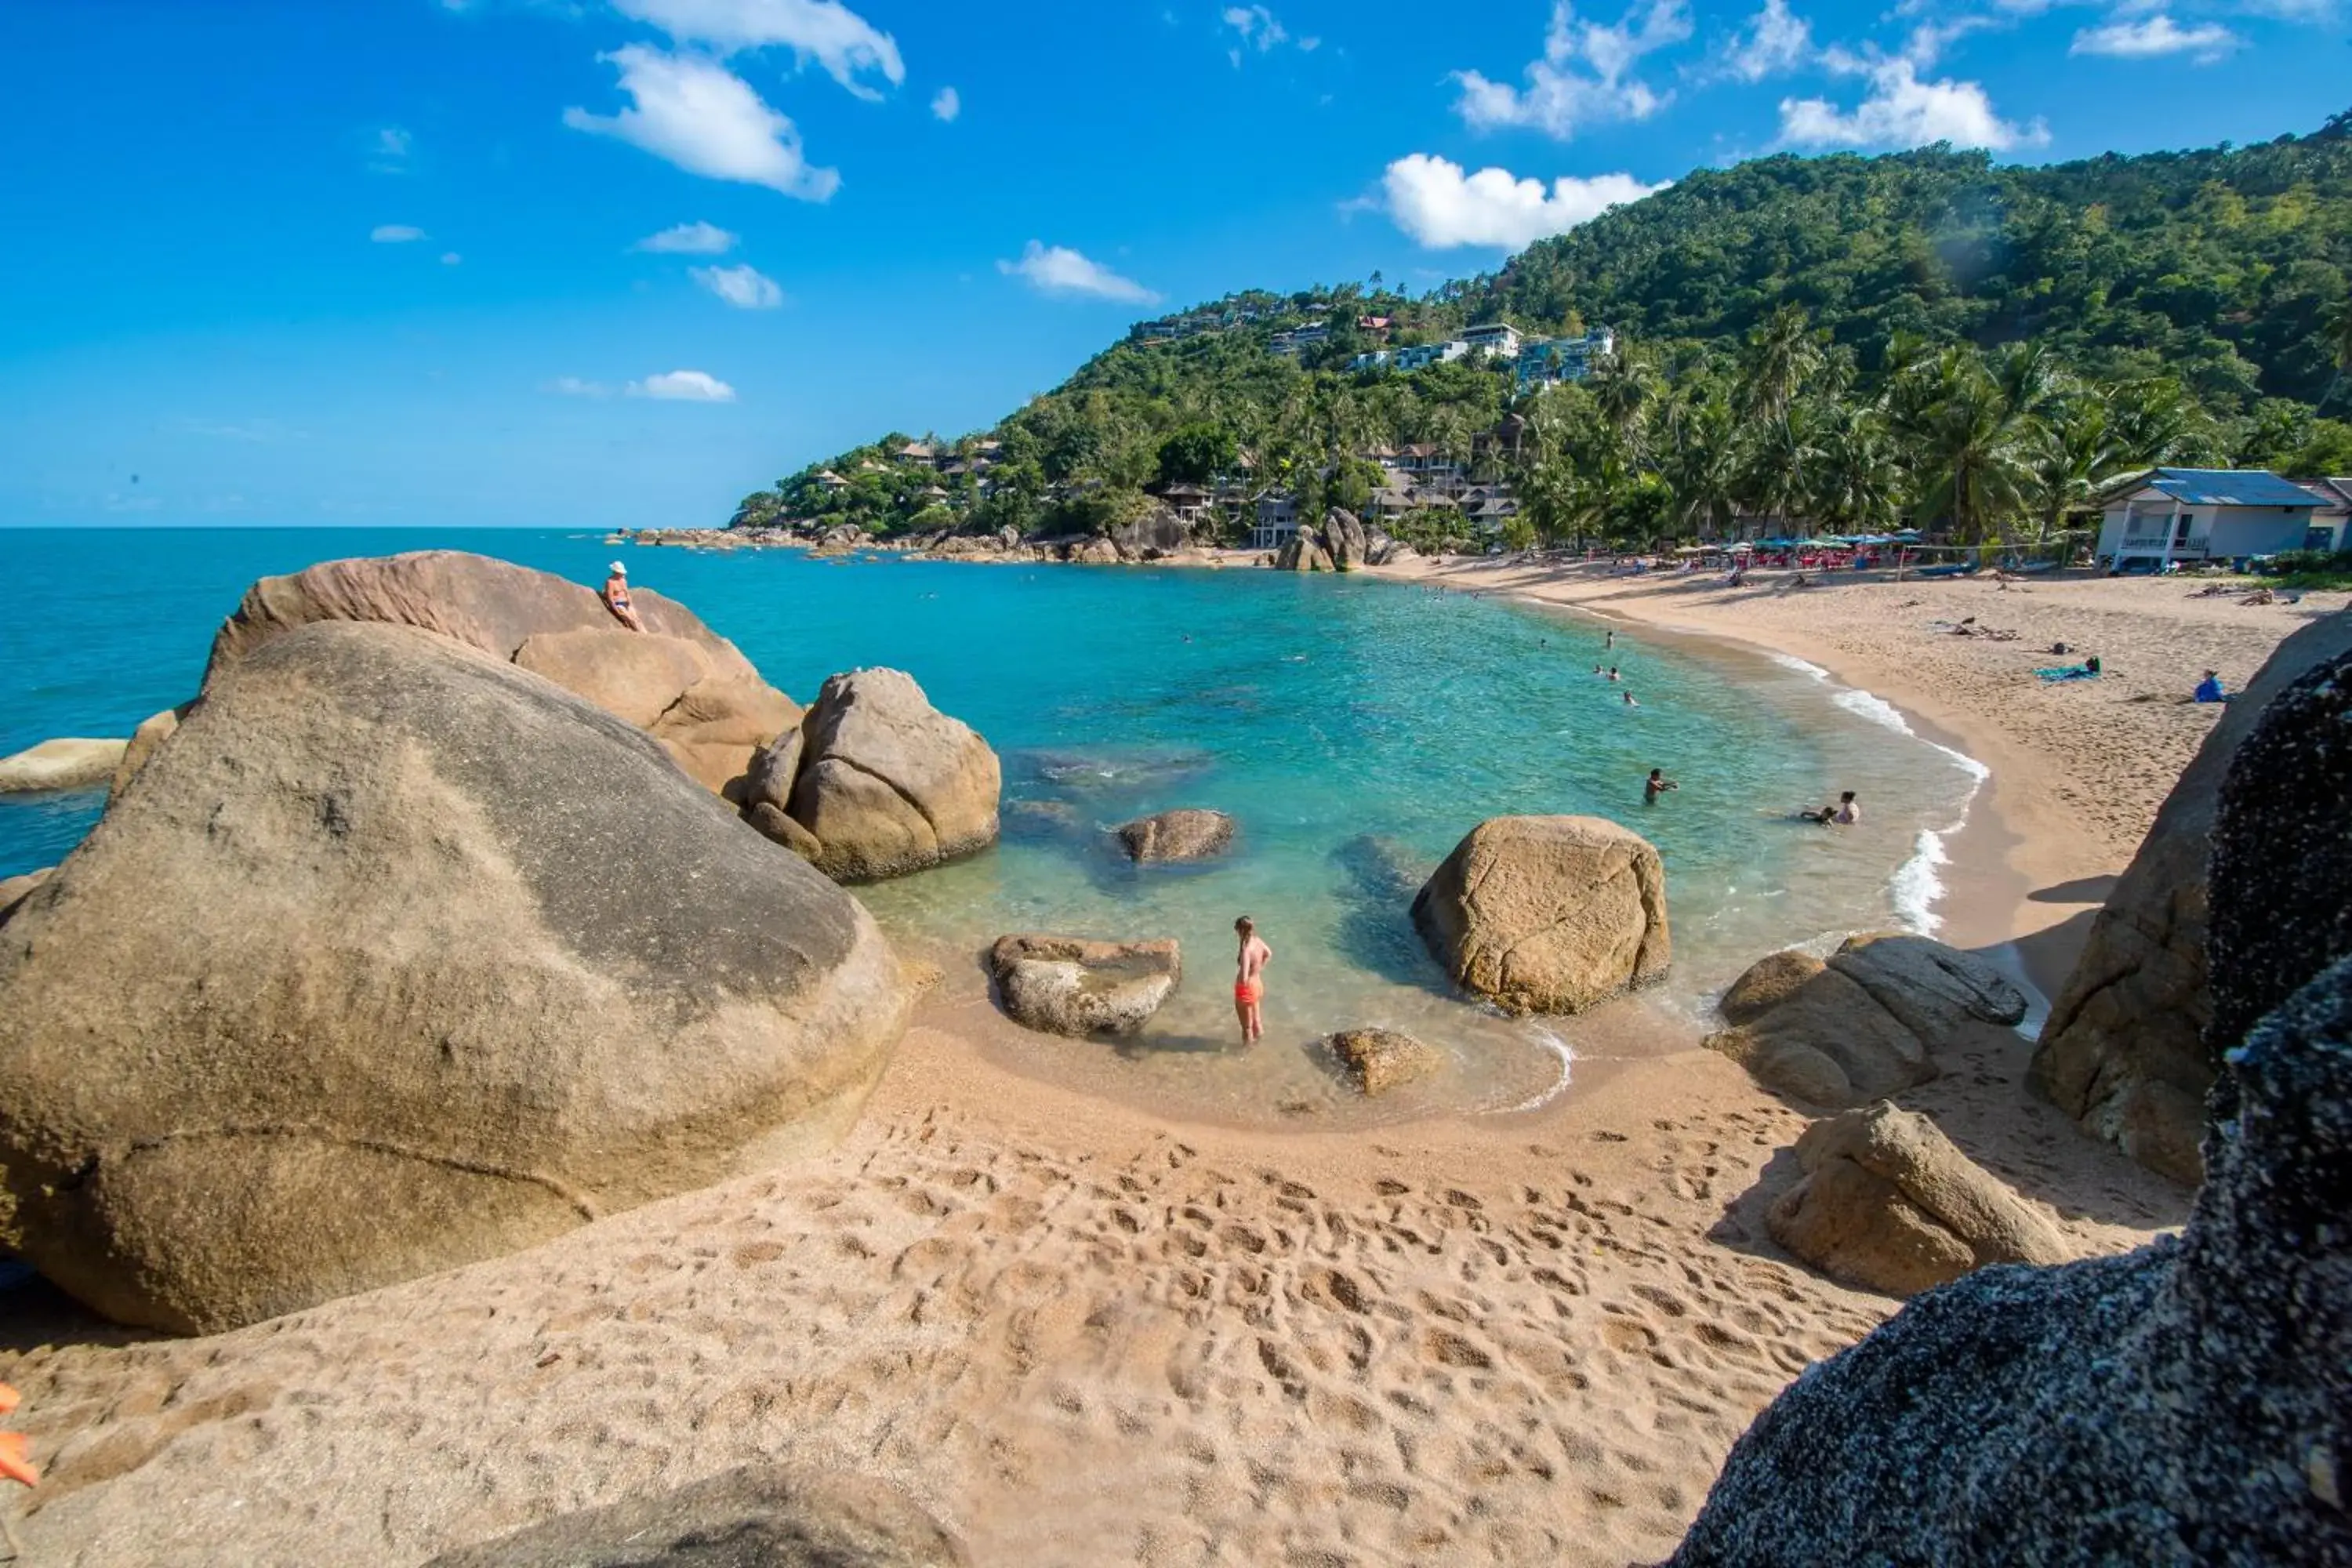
(2098, 468), (2319, 572)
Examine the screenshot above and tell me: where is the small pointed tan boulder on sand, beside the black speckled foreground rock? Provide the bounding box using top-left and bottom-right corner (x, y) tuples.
(1764, 1100), (2074, 1295)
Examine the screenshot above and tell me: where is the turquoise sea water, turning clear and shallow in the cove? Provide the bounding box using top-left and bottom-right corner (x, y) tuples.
(0, 529), (1978, 1119)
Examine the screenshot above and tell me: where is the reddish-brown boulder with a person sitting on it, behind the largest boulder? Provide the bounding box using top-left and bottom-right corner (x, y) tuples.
(205, 550), (800, 789)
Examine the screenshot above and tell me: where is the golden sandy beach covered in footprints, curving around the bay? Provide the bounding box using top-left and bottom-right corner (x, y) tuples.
(0, 564), (2343, 1568)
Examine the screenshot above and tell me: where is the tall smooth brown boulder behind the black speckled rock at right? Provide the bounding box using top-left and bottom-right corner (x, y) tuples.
(2030, 612), (2352, 1182)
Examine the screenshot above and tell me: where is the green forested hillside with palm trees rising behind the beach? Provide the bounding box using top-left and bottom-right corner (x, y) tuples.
(736, 113), (2352, 550)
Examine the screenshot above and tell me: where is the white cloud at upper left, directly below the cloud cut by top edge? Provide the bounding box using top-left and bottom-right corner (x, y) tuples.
(564, 45), (842, 202)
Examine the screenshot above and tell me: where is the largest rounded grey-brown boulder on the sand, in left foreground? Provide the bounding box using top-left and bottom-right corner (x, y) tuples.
(0, 623), (908, 1330)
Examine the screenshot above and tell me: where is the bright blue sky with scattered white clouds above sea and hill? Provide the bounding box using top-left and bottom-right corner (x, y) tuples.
(0, 0), (2352, 527)
